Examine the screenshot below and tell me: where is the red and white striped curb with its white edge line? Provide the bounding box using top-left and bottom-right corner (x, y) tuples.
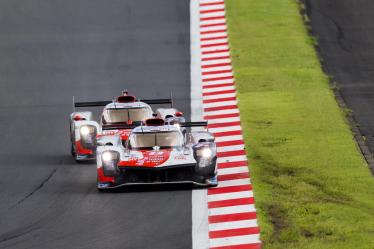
(191, 0), (261, 249)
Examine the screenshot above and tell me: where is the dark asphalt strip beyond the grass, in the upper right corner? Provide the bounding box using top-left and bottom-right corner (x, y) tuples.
(306, 0), (374, 152)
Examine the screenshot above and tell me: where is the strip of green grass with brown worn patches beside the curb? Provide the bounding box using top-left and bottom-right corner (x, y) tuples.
(226, 0), (374, 249)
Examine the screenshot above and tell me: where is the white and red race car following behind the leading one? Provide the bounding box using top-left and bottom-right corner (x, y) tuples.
(70, 91), (184, 161)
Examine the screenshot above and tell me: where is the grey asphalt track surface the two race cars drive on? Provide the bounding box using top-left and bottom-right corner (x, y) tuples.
(0, 0), (192, 249)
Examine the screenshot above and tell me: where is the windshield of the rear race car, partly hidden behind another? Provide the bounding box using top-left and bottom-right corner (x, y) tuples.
(104, 108), (151, 123)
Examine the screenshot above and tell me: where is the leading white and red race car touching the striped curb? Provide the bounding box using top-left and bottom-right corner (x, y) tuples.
(96, 118), (217, 190)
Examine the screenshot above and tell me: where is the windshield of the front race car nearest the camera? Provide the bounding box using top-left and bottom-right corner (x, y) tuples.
(129, 131), (183, 149)
